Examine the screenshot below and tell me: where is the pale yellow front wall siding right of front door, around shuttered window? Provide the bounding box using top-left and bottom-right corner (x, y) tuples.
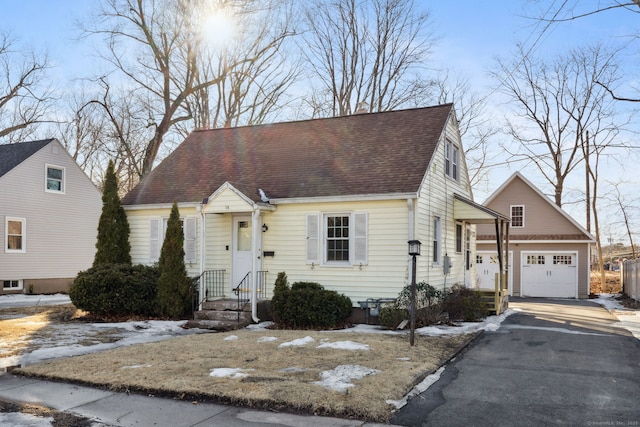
(263, 200), (408, 305)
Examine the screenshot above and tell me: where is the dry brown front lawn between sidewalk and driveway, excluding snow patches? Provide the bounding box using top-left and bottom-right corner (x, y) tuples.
(15, 324), (473, 422)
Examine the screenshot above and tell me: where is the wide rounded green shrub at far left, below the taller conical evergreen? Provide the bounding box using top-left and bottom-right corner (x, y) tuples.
(69, 264), (158, 316)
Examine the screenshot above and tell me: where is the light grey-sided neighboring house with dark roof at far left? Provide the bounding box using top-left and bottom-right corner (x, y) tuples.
(0, 139), (102, 294)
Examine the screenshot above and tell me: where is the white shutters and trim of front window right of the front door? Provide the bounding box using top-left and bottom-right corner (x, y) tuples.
(306, 212), (369, 267)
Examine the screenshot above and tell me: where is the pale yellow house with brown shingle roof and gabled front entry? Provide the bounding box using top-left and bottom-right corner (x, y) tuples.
(122, 104), (504, 320)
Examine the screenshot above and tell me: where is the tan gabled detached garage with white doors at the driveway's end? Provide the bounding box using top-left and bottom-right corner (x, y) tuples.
(476, 173), (594, 298)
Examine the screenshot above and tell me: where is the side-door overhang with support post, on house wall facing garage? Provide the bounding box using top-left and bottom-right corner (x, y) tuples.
(453, 194), (511, 306)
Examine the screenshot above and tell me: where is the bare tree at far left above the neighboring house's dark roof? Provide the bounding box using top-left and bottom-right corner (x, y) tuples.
(0, 33), (53, 142)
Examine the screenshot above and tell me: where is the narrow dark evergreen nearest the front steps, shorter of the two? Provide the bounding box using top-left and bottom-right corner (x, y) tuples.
(156, 202), (191, 319)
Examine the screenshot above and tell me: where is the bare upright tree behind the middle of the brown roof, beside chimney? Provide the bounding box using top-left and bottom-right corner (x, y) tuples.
(302, 0), (433, 116)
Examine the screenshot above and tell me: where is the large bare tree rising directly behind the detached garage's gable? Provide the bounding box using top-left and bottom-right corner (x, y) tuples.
(493, 46), (626, 206)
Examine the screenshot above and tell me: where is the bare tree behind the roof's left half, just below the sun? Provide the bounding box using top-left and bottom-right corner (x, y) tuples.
(181, 0), (299, 128)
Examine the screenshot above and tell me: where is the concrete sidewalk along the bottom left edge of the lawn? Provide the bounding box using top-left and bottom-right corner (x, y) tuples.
(0, 373), (392, 427)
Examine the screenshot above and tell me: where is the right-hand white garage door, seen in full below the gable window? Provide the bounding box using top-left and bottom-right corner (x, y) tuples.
(520, 252), (578, 298)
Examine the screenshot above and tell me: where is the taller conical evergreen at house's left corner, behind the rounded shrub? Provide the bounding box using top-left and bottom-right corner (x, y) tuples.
(93, 160), (131, 267)
